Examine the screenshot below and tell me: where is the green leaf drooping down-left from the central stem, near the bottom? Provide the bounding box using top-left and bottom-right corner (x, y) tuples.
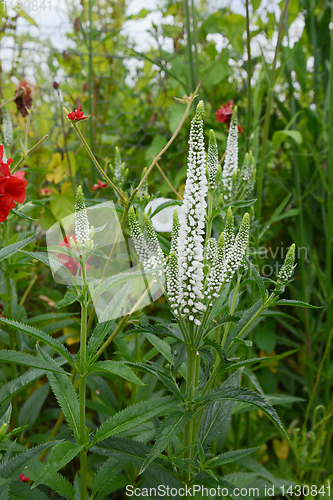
(139, 410), (193, 474)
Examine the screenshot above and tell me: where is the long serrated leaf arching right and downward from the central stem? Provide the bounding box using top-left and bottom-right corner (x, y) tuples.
(196, 387), (289, 439)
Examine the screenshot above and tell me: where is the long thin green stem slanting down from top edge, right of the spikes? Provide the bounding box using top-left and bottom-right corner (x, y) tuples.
(257, 0), (289, 245)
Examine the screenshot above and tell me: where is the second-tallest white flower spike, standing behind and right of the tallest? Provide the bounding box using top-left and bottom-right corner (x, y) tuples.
(222, 107), (238, 199)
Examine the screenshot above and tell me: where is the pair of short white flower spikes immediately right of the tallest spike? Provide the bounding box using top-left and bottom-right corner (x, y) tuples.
(205, 210), (250, 305)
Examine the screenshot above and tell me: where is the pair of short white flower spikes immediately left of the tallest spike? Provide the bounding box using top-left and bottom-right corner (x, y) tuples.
(128, 207), (164, 275)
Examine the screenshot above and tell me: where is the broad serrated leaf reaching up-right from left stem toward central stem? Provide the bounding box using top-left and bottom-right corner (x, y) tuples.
(92, 396), (175, 445)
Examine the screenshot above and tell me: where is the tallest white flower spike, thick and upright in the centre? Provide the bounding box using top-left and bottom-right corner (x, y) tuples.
(178, 101), (207, 325)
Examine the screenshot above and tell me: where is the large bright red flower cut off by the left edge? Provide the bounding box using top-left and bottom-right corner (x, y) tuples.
(0, 145), (28, 222)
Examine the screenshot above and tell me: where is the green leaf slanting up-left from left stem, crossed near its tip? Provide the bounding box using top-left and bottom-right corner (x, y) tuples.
(37, 346), (83, 444)
